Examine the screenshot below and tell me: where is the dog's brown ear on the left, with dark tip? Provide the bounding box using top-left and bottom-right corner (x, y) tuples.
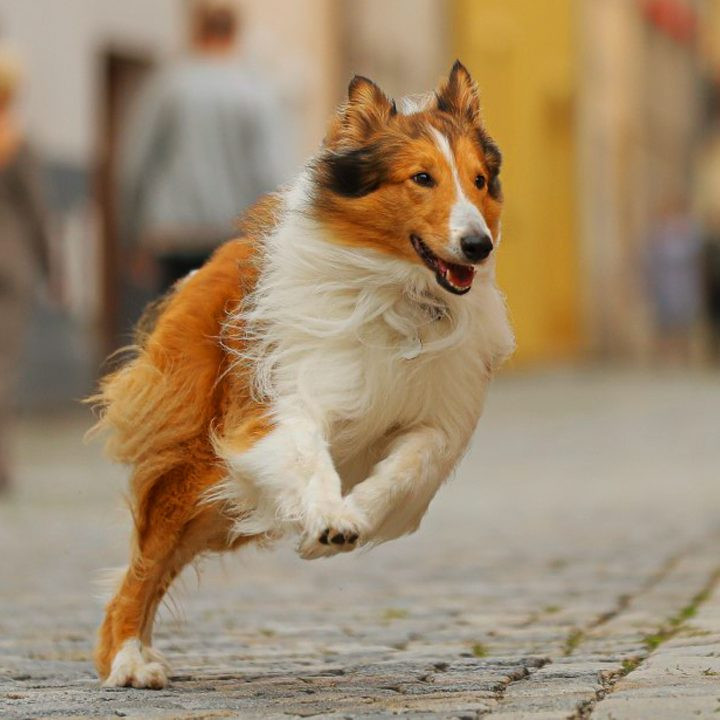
(325, 75), (397, 144)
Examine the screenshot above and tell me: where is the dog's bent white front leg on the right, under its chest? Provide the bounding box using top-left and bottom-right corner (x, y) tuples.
(346, 426), (466, 544)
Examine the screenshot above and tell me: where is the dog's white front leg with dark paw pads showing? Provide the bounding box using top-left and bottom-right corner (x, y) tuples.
(222, 406), (366, 559)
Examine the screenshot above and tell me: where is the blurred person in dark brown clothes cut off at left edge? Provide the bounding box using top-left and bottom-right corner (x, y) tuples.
(0, 48), (49, 493)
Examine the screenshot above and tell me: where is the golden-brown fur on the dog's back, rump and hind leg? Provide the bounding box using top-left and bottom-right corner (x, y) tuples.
(91, 197), (276, 677)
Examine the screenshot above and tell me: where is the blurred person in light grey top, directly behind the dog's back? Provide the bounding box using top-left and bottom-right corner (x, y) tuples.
(119, 0), (282, 290)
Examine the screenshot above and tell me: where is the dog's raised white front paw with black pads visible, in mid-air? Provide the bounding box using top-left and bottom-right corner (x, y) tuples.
(298, 503), (365, 560)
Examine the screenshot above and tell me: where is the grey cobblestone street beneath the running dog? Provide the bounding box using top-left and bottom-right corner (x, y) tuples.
(0, 372), (720, 720)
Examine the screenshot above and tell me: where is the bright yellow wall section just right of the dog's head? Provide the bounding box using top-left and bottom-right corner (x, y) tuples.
(452, 0), (580, 363)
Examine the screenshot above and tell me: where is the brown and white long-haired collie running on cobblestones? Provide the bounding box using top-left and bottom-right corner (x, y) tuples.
(91, 62), (514, 688)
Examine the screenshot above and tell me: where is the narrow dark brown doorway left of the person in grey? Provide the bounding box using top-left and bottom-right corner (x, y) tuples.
(96, 47), (154, 355)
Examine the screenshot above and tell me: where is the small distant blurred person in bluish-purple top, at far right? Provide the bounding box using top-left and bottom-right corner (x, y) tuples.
(647, 198), (702, 362)
